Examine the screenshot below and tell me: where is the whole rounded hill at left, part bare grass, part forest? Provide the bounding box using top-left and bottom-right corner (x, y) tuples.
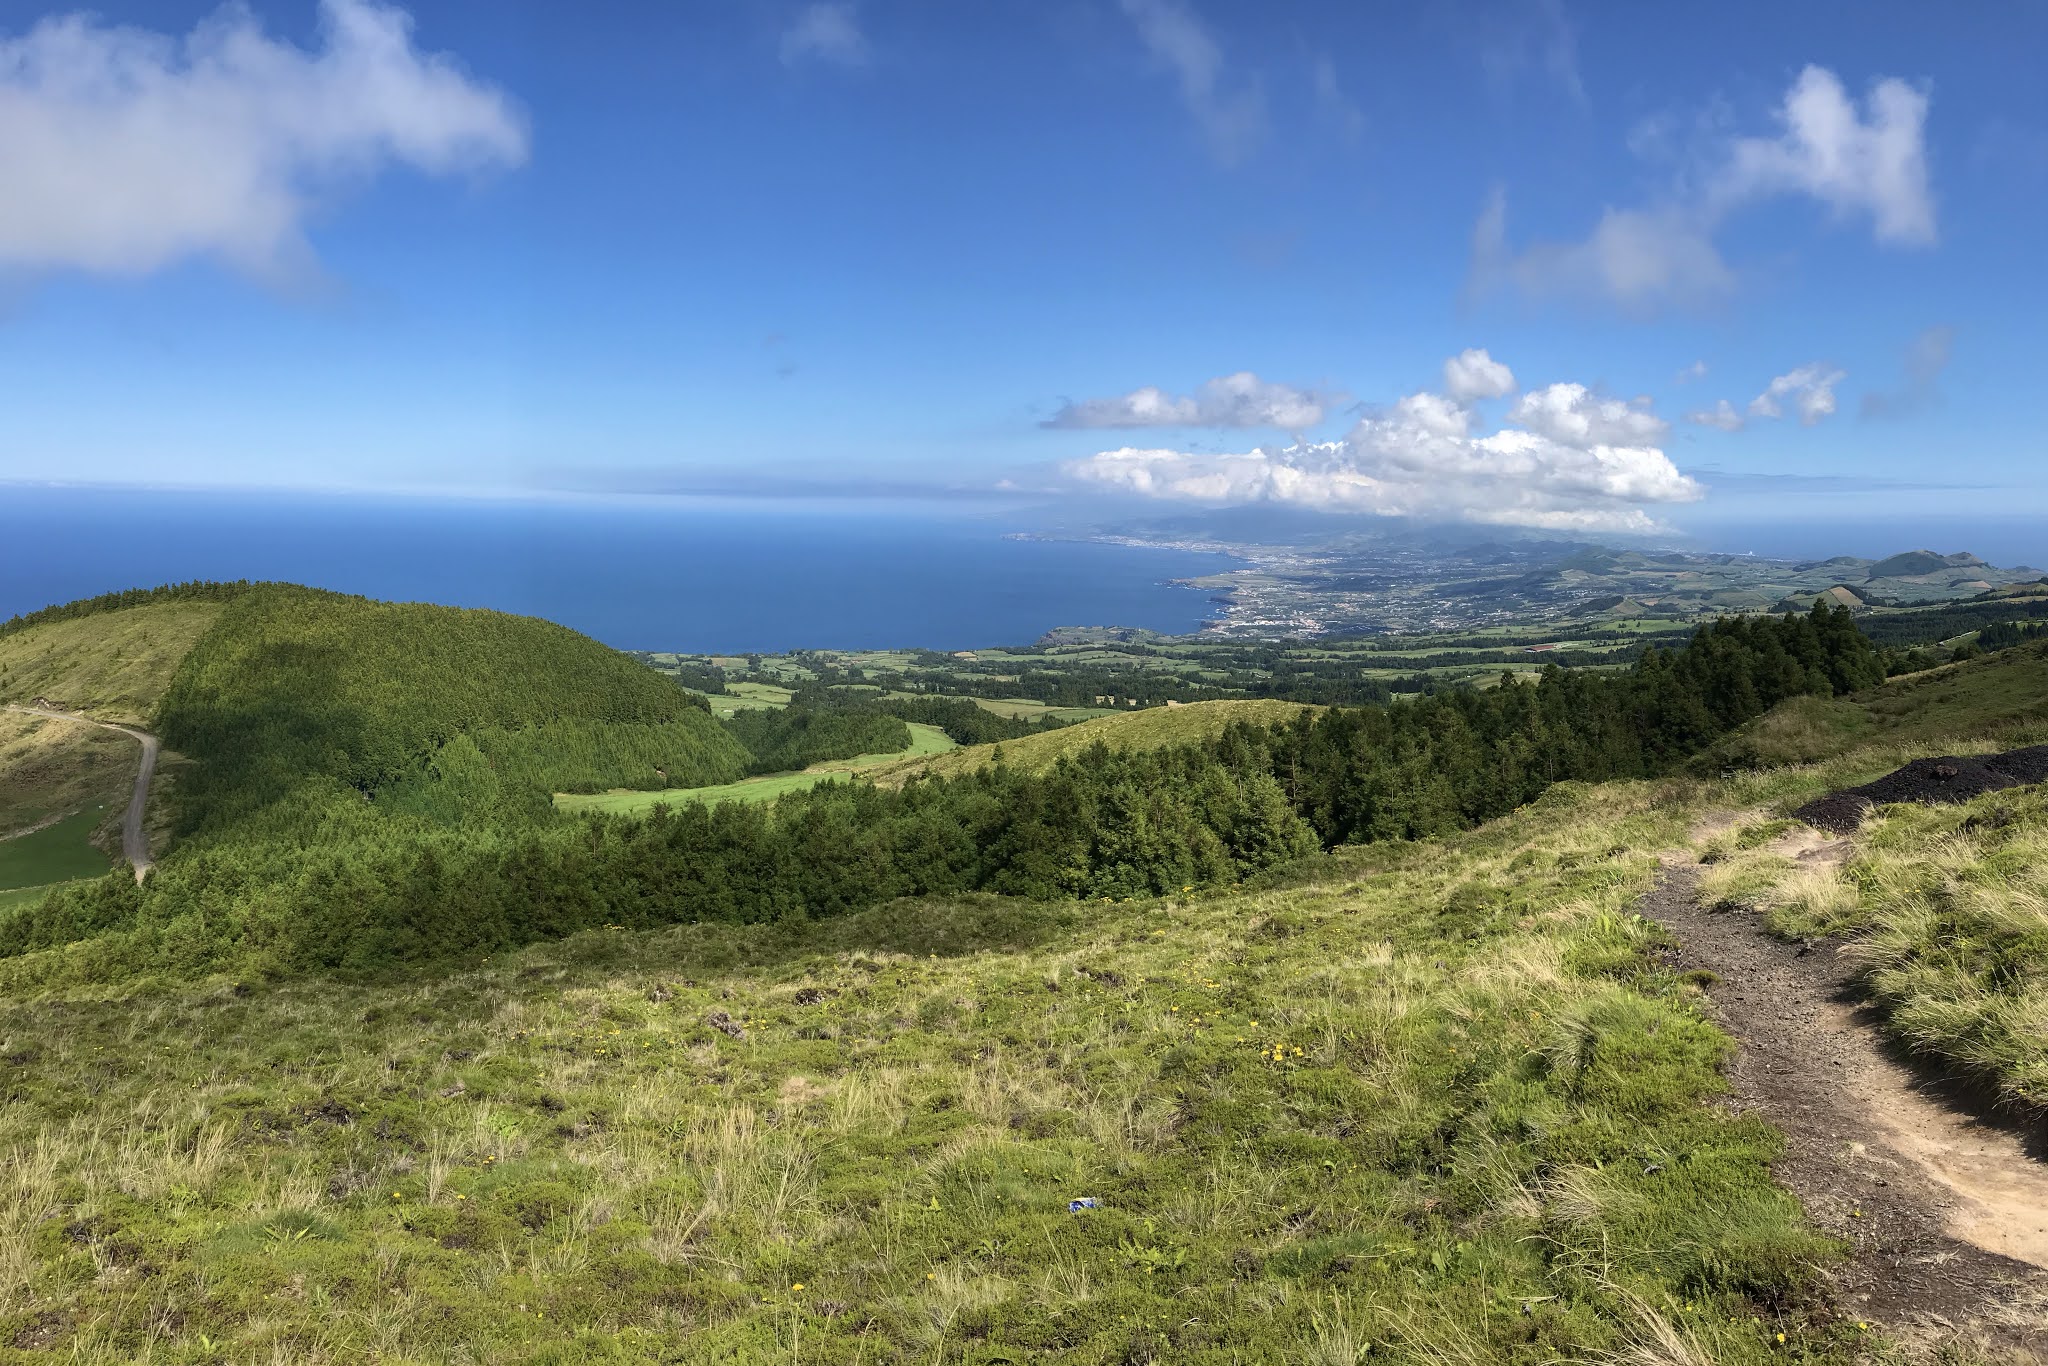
(0, 584), (752, 977)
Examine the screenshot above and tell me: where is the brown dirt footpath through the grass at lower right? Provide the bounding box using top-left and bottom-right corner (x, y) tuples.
(1640, 847), (2048, 1352)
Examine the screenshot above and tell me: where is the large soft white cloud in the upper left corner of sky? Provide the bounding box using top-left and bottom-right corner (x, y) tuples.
(0, 0), (526, 276)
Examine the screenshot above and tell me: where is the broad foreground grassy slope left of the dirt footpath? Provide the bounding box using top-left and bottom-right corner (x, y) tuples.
(0, 784), (1855, 1366)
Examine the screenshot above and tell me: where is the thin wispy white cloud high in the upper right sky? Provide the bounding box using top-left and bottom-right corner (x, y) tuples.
(1473, 66), (1937, 313)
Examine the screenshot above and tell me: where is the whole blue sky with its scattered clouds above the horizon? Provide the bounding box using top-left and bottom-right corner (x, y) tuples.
(0, 0), (2048, 544)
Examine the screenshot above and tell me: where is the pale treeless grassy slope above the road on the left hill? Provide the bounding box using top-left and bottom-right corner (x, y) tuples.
(0, 602), (223, 725)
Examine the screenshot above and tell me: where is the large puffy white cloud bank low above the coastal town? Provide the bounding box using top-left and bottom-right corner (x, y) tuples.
(1065, 350), (1704, 530)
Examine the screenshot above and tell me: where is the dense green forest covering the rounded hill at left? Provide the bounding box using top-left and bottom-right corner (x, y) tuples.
(158, 584), (748, 834)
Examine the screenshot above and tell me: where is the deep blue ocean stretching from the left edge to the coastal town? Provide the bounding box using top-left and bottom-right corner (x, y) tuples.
(0, 485), (1237, 653)
